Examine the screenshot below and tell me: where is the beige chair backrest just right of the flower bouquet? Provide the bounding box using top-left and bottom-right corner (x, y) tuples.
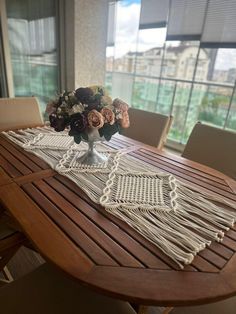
(122, 108), (172, 149)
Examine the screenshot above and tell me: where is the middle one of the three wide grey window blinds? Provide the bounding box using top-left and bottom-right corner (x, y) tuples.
(167, 0), (207, 40)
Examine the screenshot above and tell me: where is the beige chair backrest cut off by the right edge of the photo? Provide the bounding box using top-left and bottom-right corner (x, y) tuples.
(182, 122), (236, 179)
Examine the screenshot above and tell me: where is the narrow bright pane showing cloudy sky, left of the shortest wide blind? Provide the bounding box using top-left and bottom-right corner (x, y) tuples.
(114, 0), (141, 72)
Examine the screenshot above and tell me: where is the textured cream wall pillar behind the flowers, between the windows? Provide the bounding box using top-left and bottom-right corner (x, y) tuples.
(61, 0), (108, 89)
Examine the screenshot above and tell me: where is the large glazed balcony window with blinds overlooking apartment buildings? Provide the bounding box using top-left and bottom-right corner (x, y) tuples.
(106, 0), (236, 143)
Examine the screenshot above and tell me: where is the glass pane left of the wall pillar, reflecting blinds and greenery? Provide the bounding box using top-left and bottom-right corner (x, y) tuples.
(6, 0), (58, 112)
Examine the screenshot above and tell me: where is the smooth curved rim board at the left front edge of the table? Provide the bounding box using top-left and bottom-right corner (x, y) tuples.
(0, 183), (94, 280)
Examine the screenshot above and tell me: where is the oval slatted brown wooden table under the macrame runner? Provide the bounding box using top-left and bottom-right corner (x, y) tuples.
(0, 135), (236, 306)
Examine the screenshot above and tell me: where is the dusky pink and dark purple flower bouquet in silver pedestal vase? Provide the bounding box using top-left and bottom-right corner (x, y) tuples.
(46, 86), (129, 165)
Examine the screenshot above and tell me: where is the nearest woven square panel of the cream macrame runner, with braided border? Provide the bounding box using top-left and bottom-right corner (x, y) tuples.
(100, 173), (177, 211)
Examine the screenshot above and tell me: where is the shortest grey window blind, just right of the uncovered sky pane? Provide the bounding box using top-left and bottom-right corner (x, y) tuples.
(139, 0), (169, 29)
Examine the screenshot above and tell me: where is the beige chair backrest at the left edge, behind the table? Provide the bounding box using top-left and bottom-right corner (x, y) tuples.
(0, 97), (43, 131)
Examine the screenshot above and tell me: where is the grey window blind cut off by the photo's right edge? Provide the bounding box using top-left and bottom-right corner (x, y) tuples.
(201, 0), (236, 48)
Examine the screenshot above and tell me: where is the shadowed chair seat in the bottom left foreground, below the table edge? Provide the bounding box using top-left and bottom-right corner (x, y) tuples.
(0, 263), (135, 314)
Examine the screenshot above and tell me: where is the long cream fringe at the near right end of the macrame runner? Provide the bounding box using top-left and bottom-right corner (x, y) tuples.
(106, 184), (236, 268)
